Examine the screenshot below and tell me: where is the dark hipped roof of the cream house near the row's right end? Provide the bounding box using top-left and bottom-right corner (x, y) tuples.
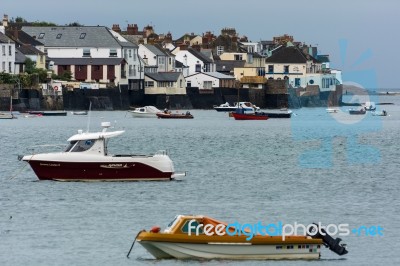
(265, 46), (318, 64)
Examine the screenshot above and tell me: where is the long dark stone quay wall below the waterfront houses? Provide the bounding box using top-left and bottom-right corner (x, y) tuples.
(0, 83), (342, 112)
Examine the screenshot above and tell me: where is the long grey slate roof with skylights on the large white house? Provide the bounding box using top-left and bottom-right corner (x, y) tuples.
(22, 26), (121, 48)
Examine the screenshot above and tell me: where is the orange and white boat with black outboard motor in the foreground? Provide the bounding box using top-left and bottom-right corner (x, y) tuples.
(127, 215), (348, 260)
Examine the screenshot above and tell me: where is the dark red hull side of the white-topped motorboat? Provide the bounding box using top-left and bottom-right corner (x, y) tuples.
(29, 161), (173, 181)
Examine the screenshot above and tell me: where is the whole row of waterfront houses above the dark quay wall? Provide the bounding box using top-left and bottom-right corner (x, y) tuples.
(0, 17), (342, 101)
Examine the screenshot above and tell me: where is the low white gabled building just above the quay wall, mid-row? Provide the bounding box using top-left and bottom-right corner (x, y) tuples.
(186, 72), (236, 90)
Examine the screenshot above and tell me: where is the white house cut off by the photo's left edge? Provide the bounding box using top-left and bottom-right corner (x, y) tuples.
(0, 32), (15, 74)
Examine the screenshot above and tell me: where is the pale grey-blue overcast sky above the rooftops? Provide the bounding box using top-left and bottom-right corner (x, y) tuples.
(0, 0), (400, 89)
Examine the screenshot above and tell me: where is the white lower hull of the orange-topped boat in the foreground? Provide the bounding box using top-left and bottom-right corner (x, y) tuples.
(139, 241), (321, 260)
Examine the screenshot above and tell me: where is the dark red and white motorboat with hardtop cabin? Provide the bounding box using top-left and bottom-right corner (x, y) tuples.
(22, 122), (183, 181)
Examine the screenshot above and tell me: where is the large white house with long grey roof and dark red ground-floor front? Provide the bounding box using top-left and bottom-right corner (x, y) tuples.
(22, 26), (143, 89)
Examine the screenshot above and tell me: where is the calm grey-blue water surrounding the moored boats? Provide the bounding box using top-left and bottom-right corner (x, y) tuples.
(0, 96), (400, 265)
